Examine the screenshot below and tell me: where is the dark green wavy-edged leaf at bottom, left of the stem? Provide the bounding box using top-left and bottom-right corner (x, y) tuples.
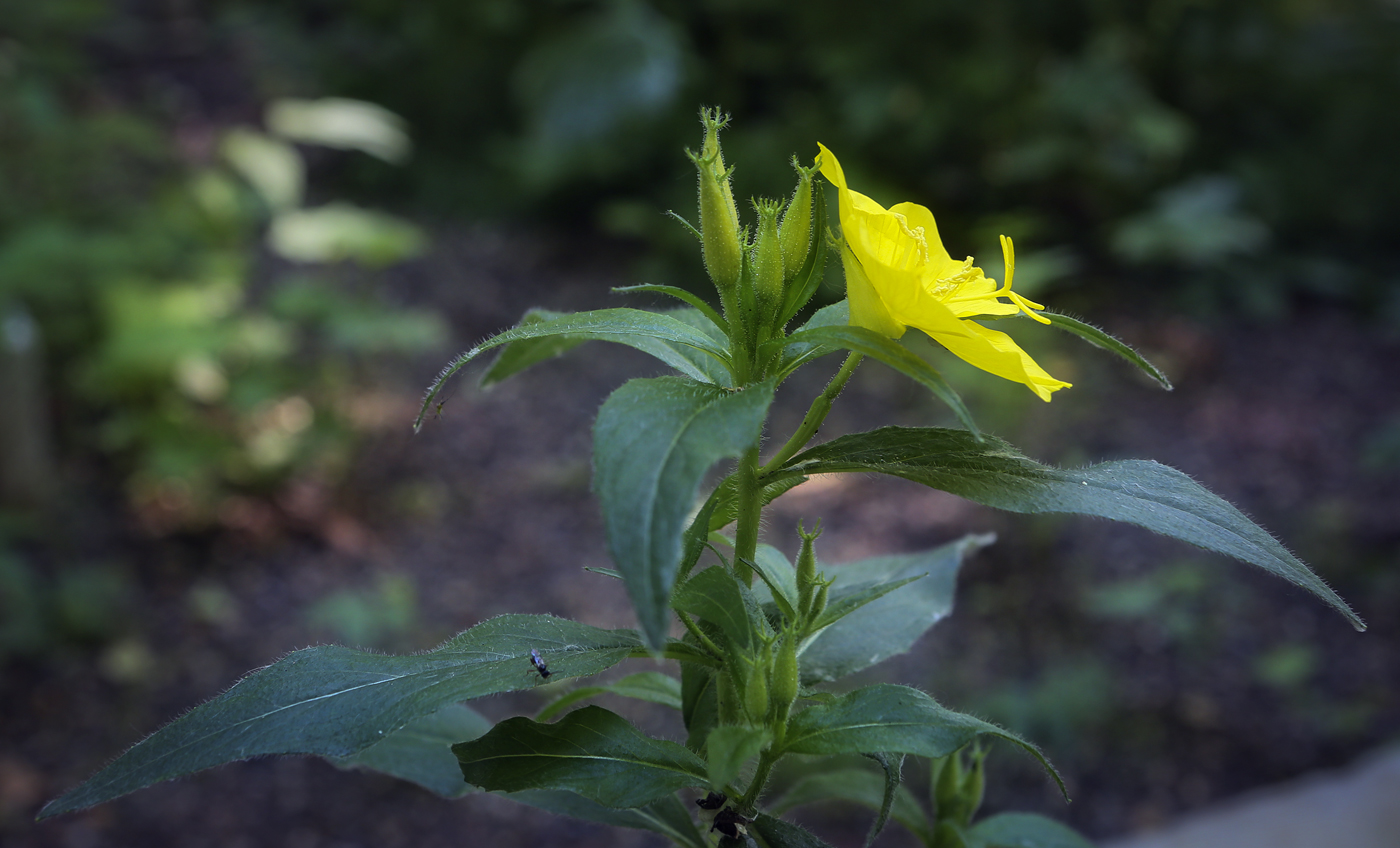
(452, 707), (708, 807)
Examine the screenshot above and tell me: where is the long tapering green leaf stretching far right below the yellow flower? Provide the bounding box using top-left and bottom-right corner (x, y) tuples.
(789, 427), (1366, 630)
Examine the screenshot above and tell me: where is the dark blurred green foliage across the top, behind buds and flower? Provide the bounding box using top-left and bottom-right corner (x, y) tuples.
(229, 0), (1400, 315)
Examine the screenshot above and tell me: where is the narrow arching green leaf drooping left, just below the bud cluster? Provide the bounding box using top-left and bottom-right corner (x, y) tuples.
(413, 309), (729, 430)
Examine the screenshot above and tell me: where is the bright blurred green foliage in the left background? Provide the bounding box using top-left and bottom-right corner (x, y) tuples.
(0, 0), (445, 532)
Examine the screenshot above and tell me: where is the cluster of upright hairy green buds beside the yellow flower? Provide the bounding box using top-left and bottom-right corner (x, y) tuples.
(686, 109), (820, 377)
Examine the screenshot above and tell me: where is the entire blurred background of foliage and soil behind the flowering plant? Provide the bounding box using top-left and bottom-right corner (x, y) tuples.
(0, 0), (1400, 848)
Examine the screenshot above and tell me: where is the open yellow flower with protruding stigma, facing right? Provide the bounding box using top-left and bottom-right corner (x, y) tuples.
(818, 144), (1070, 400)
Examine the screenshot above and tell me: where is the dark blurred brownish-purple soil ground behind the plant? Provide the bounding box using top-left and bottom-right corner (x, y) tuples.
(0, 232), (1400, 848)
